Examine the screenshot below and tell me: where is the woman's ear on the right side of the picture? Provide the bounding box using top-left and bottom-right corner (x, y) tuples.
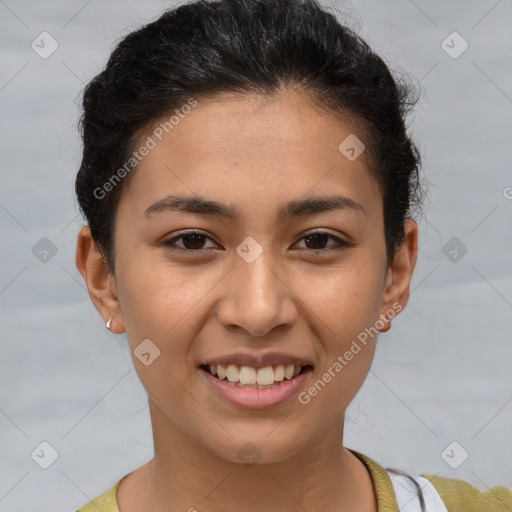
(380, 219), (418, 332)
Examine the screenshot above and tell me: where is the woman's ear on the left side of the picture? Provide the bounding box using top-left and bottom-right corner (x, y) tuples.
(75, 226), (125, 334)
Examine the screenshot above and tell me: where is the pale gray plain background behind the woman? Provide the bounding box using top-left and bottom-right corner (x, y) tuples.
(0, 0), (512, 512)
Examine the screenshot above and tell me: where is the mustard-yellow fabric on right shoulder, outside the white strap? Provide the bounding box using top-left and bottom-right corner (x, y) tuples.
(421, 473), (512, 512)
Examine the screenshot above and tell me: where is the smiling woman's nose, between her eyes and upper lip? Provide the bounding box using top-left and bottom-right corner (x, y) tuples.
(217, 246), (298, 336)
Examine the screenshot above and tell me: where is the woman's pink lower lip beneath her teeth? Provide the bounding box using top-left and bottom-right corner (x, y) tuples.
(199, 368), (311, 409)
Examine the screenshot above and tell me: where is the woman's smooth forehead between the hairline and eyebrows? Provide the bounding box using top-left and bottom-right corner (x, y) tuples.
(120, 92), (382, 223)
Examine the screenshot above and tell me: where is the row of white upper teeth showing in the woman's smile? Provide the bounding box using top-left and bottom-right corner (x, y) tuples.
(210, 364), (302, 386)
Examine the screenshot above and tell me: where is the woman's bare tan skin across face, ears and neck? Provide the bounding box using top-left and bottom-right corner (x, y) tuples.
(76, 91), (418, 512)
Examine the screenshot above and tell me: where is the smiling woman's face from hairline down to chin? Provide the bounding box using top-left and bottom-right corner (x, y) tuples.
(79, 92), (416, 462)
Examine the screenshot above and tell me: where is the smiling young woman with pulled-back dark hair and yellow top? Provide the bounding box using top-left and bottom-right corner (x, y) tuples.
(76, 0), (512, 512)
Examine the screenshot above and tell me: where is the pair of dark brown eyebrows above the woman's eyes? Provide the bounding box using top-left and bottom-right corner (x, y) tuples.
(142, 195), (367, 222)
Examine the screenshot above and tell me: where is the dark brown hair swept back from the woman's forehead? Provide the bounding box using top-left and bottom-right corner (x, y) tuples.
(75, 0), (422, 273)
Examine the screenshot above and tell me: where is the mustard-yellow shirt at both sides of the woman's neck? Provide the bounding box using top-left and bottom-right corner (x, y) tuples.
(76, 450), (512, 512)
